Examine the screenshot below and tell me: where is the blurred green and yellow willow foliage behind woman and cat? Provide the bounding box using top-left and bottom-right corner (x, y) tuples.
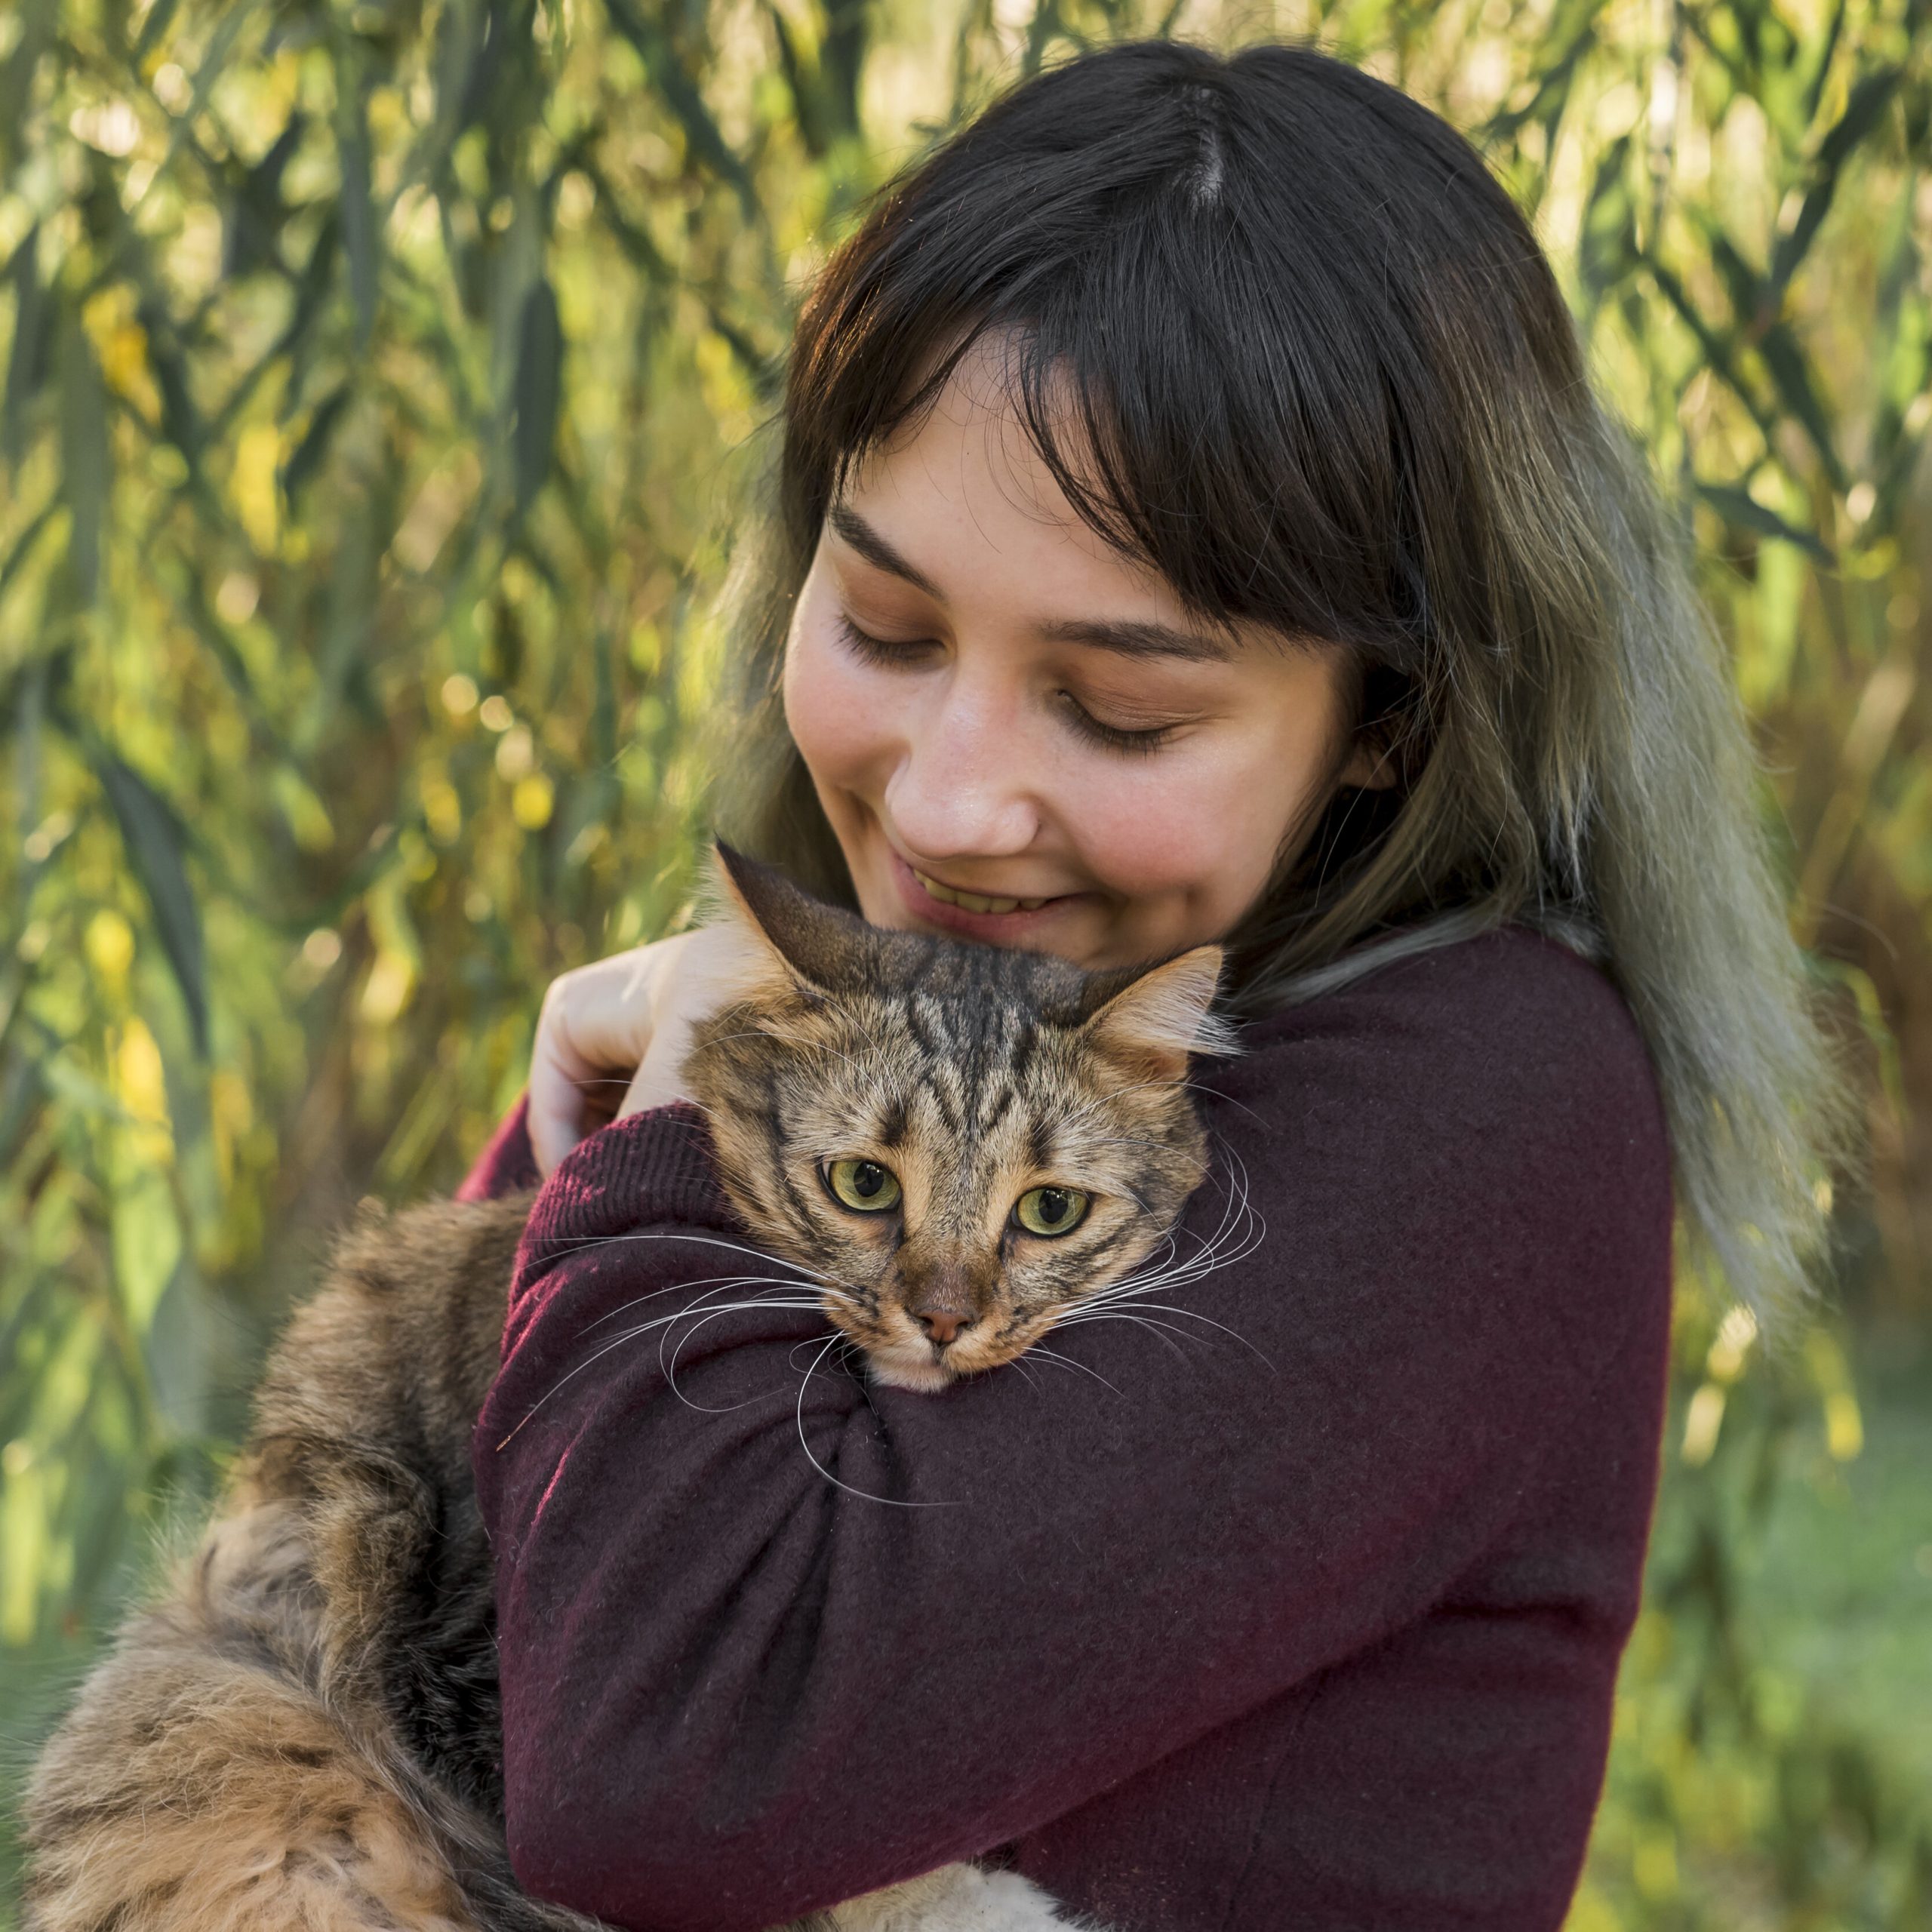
(0, 0), (1932, 1932)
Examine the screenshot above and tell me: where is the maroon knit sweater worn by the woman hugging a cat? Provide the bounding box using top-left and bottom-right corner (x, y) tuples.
(466, 933), (1671, 1932)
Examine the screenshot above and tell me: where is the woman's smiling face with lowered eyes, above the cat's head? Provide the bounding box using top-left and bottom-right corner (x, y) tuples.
(784, 348), (1376, 968)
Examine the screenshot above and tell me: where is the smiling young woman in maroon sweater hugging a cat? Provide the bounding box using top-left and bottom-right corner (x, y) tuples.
(452, 45), (1832, 1932)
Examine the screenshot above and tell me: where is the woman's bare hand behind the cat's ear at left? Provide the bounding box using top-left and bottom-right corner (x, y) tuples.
(529, 925), (764, 1174)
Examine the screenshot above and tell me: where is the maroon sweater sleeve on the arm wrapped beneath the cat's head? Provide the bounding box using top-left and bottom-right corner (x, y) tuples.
(473, 935), (1671, 1932)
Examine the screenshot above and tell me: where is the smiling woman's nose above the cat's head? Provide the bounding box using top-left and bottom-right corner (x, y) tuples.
(884, 686), (1041, 860)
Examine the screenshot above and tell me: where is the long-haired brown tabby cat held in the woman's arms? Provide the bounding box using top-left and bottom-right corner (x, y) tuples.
(25, 854), (1225, 1932)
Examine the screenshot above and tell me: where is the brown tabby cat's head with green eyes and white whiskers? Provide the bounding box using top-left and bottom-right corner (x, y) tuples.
(686, 850), (1229, 1389)
